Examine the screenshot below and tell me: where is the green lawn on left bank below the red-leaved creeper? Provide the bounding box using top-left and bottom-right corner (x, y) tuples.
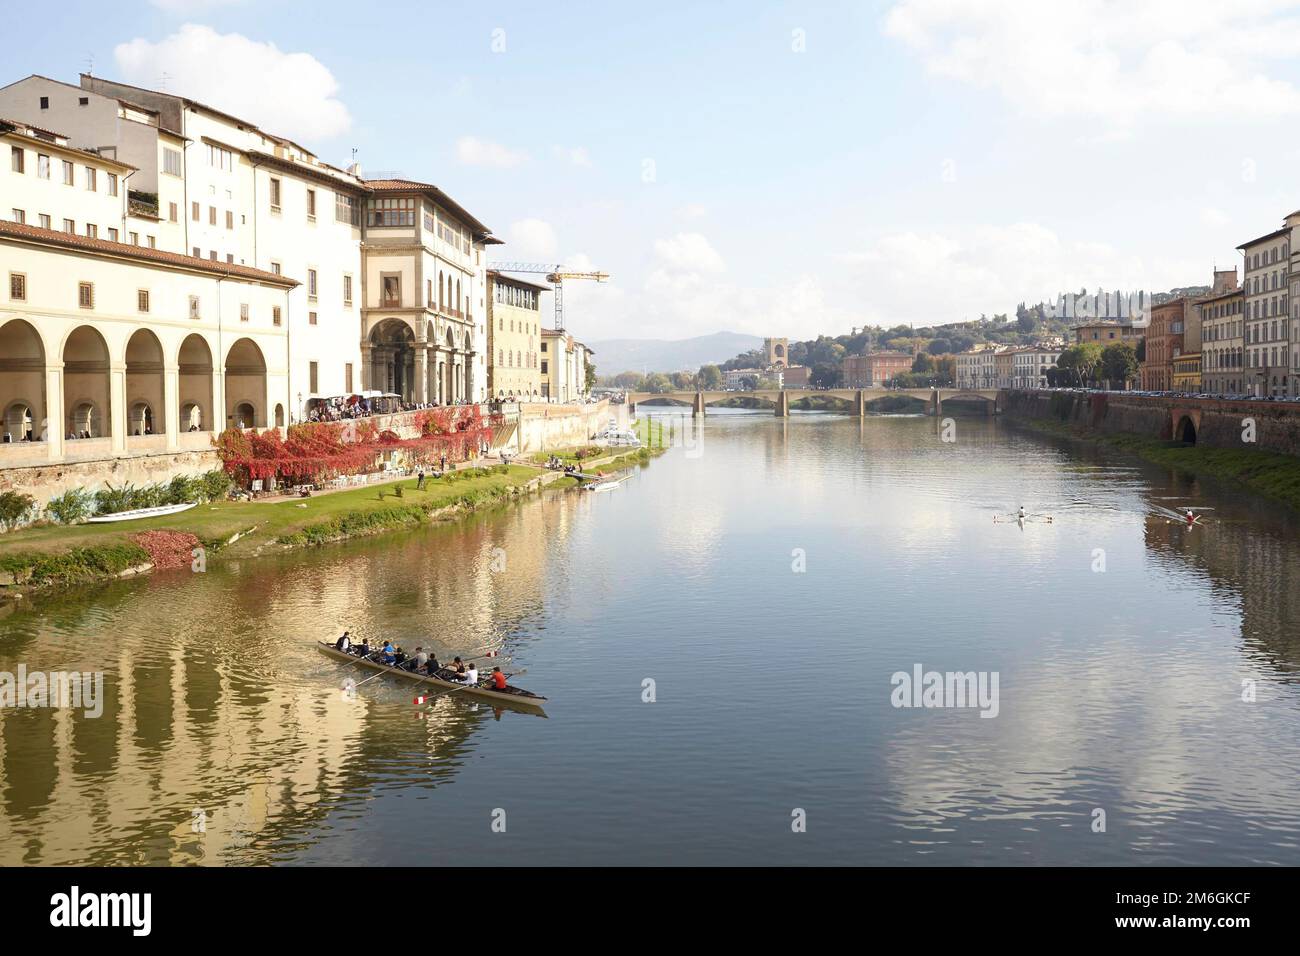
(0, 466), (538, 576)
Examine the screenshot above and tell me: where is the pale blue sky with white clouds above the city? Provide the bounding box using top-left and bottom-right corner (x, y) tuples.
(12, 0), (1300, 351)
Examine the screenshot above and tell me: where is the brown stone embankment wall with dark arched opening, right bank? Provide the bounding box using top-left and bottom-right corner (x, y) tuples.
(998, 390), (1300, 455)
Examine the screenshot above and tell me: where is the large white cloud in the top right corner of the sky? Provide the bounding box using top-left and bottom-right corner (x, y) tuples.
(884, 0), (1300, 126)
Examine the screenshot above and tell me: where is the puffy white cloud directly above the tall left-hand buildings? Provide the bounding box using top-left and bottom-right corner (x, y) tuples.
(113, 23), (352, 139)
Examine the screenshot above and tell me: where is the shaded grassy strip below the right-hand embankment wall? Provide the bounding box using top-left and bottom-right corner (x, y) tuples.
(1008, 418), (1300, 511)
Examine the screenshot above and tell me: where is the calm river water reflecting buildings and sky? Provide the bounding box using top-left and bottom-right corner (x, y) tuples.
(0, 412), (1300, 865)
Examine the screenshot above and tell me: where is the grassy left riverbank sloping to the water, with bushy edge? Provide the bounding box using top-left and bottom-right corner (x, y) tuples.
(0, 466), (540, 585)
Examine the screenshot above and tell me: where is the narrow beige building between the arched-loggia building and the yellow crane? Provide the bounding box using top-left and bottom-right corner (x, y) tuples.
(488, 269), (550, 402)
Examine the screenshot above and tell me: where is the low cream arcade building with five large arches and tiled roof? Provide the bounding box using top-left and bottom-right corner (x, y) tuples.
(0, 222), (296, 470)
